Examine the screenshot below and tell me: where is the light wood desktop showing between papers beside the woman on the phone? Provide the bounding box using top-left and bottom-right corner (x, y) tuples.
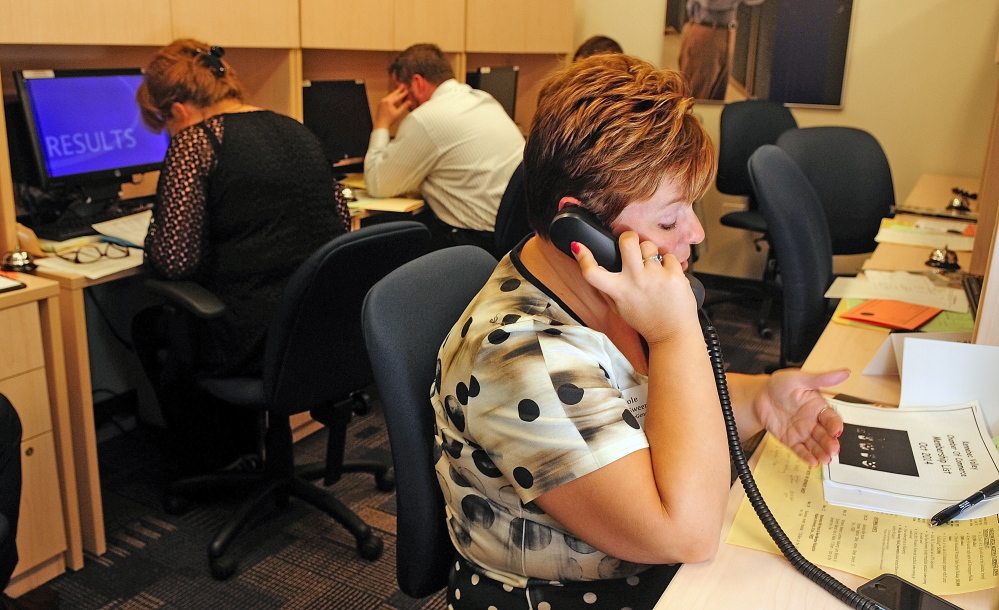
(656, 204), (997, 610)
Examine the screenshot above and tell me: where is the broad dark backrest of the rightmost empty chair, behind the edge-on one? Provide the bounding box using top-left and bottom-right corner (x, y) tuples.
(777, 127), (895, 255)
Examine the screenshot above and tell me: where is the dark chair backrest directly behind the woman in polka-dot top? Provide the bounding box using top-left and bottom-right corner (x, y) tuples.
(362, 246), (496, 597)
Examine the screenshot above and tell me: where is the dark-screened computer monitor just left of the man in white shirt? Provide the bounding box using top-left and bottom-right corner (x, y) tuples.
(302, 80), (373, 174)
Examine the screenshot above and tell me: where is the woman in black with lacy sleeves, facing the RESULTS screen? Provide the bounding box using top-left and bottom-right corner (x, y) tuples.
(133, 39), (350, 470)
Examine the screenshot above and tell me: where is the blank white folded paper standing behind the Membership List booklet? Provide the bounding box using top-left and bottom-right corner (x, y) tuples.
(899, 337), (999, 437)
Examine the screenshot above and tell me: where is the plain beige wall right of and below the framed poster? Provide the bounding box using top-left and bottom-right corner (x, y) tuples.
(696, 0), (999, 278)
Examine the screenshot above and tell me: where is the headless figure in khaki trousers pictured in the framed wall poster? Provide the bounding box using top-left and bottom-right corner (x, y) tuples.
(679, 0), (764, 100)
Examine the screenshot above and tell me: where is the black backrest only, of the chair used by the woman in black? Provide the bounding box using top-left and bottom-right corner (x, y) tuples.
(264, 221), (430, 415)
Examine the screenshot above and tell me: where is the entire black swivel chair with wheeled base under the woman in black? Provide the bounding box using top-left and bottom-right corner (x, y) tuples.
(147, 221), (430, 580)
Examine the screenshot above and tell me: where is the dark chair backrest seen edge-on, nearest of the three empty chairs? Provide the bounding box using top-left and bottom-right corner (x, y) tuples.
(747, 145), (833, 368)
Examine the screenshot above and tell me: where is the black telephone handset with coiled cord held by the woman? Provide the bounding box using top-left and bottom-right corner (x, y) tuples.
(549, 205), (884, 610)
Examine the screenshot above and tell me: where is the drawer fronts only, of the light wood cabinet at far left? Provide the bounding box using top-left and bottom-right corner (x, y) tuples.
(0, 302), (66, 591)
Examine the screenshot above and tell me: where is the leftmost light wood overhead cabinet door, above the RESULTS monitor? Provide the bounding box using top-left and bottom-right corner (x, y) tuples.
(0, 0), (170, 45)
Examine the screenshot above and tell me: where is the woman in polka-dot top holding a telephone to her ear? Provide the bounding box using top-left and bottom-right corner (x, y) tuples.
(432, 55), (848, 610)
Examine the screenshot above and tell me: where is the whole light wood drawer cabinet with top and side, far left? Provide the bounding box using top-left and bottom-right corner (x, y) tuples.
(0, 274), (83, 597)
